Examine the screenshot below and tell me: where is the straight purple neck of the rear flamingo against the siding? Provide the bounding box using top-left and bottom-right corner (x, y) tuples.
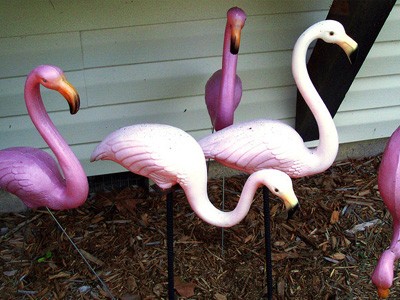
(214, 22), (238, 130)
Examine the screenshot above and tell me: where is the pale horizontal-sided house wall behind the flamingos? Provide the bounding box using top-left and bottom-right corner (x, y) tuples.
(0, 0), (400, 175)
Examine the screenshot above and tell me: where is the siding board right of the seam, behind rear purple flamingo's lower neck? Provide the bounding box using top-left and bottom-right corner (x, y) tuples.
(85, 51), (293, 106)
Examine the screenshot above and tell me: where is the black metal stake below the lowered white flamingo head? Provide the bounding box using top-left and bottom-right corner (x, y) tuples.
(263, 186), (273, 300)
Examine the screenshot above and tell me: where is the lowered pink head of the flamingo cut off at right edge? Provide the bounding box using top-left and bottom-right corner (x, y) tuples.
(371, 249), (396, 299)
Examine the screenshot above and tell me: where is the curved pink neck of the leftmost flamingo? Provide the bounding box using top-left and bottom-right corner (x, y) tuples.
(24, 73), (88, 209)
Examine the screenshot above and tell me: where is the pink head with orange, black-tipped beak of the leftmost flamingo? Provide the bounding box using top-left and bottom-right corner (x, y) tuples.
(32, 65), (80, 114)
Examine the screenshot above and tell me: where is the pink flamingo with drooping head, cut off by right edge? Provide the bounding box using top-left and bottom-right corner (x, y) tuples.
(372, 127), (400, 299)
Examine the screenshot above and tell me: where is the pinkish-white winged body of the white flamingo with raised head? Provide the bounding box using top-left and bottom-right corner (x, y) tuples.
(199, 120), (307, 177)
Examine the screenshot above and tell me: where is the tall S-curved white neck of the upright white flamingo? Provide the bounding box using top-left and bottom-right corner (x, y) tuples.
(292, 27), (339, 173)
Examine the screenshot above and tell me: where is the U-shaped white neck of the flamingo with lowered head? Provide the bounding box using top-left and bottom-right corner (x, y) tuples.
(181, 170), (268, 227)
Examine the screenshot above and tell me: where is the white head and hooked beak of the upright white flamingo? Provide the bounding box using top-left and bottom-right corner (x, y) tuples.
(314, 20), (358, 63)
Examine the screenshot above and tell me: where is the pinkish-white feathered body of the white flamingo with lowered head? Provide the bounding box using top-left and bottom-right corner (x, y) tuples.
(91, 124), (207, 189)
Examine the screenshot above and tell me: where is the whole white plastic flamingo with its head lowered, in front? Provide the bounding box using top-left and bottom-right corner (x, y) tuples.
(90, 124), (298, 227)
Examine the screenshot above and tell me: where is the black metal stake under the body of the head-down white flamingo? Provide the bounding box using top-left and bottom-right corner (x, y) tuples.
(167, 191), (175, 300)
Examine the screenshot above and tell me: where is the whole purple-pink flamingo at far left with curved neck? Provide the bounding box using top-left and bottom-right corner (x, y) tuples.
(0, 65), (89, 210)
